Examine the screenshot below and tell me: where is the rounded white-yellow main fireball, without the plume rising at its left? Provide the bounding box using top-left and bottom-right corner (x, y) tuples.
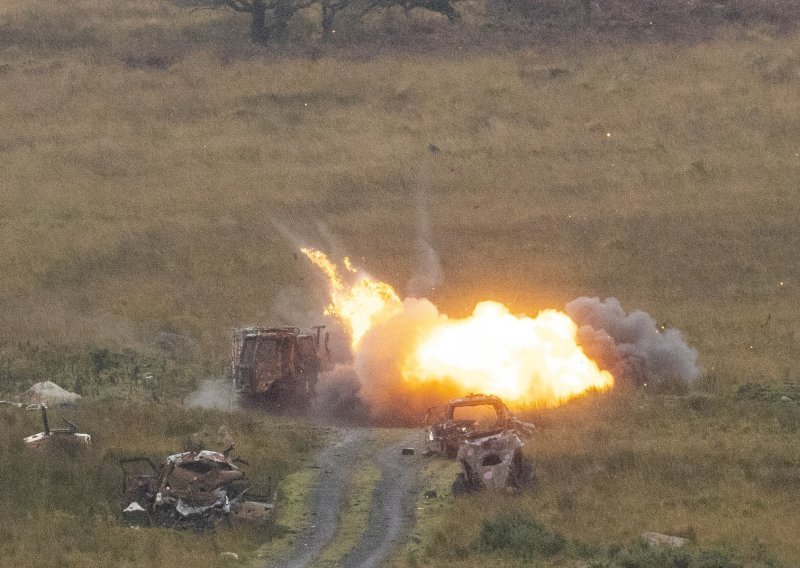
(403, 302), (614, 406)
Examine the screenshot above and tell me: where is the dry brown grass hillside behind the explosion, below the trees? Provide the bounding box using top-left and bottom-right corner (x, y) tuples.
(0, 12), (800, 386)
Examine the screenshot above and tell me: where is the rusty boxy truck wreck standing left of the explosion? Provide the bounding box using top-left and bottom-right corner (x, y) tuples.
(231, 326), (330, 406)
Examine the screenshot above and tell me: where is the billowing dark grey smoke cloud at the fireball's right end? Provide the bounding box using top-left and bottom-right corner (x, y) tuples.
(564, 297), (701, 386)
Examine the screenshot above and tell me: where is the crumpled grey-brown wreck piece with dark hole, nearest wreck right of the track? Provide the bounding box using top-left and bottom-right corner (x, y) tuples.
(452, 430), (536, 495)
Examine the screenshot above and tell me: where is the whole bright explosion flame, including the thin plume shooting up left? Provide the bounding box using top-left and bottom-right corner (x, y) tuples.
(301, 248), (614, 406)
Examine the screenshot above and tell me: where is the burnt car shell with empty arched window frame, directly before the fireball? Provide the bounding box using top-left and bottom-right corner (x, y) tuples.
(425, 394), (534, 458)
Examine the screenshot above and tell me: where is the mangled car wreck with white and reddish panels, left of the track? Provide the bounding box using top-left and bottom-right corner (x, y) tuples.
(120, 449), (275, 530)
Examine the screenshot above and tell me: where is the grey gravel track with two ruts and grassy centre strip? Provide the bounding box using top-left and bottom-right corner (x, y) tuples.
(276, 428), (422, 568)
